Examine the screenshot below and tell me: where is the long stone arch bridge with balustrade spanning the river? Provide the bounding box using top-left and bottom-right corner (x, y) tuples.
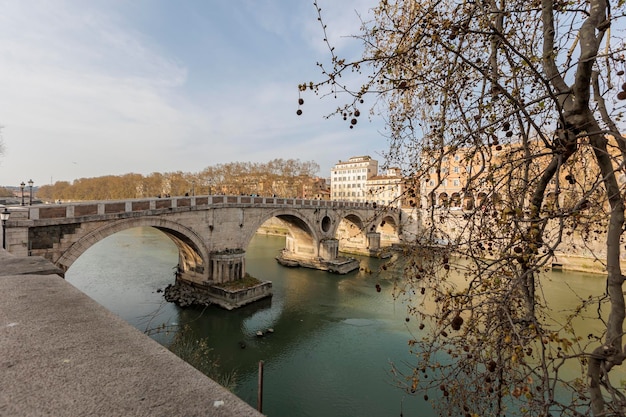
(4, 195), (402, 285)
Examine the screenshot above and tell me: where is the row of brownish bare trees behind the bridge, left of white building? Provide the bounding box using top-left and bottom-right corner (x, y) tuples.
(37, 159), (319, 201)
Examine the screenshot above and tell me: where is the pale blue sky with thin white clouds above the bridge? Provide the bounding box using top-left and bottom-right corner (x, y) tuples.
(0, 0), (387, 186)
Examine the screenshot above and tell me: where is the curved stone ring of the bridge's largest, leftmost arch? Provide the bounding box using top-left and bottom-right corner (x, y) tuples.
(55, 217), (209, 278)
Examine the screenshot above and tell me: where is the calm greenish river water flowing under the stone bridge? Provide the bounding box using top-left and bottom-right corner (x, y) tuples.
(66, 228), (603, 417)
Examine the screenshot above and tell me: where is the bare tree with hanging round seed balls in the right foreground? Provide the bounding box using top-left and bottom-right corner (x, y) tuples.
(299, 0), (626, 416)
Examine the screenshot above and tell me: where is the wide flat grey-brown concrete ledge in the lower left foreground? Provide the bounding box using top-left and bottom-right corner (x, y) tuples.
(0, 272), (261, 417)
